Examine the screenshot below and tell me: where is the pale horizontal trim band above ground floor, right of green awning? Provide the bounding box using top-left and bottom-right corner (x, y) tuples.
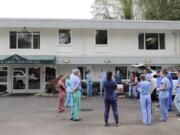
(56, 56), (180, 65)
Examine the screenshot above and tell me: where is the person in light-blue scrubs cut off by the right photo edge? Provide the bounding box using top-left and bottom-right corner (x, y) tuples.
(174, 70), (180, 116)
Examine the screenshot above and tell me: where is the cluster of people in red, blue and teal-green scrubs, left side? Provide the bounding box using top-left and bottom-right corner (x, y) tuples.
(58, 69), (82, 121)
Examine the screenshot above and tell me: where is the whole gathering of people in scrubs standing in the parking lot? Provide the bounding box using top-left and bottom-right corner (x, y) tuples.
(55, 69), (180, 126)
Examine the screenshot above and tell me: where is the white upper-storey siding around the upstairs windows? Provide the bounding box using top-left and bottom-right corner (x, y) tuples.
(0, 29), (179, 57)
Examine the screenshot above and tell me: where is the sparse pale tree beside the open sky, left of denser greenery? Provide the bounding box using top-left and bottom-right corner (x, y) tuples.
(92, 0), (133, 19)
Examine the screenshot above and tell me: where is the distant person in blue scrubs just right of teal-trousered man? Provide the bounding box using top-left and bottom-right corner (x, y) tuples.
(86, 71), (92, 96)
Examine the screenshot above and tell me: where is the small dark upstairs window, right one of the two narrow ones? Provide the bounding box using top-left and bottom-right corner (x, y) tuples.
(96, 30), (108, 45)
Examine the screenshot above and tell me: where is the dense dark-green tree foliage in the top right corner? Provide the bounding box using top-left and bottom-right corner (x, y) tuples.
(138, 0), (180, 20)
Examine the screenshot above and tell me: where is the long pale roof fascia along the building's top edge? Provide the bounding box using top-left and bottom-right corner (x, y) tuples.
(0, 18), (180, 30)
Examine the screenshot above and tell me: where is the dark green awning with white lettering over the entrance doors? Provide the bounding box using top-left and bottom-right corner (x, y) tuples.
(0, 54), (56, 64)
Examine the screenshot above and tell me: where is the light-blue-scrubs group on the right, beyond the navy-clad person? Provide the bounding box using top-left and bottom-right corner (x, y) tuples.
(137, 69), (180, 125)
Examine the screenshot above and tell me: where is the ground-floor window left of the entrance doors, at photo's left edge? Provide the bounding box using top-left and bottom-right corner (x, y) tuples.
(0, 67), (8, 91)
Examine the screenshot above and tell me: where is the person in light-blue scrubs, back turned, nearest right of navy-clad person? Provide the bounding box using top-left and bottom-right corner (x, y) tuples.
(138, 74), (152, 125)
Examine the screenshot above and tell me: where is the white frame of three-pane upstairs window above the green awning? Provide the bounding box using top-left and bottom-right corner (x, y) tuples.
(9, 30), (41, 50)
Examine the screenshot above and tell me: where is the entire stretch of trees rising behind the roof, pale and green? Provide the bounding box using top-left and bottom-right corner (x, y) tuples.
(92, 0), (180, 20)
